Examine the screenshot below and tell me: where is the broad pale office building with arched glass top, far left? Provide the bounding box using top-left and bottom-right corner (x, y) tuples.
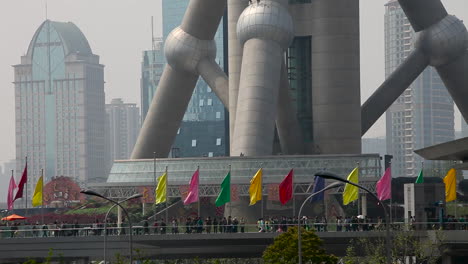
(13, 20), (108, 206)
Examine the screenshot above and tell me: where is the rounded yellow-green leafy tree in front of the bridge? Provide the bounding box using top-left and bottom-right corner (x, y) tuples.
(263, 227), (338, 264)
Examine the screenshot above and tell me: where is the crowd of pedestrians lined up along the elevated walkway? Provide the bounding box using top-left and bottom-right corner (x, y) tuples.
(0, 215), (468, 238)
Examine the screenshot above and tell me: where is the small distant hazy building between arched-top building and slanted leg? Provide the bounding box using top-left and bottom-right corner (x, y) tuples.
(106, 98), (140, 164)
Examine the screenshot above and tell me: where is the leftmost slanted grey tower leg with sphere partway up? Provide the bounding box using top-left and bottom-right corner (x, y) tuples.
(131, 0), (228, 159)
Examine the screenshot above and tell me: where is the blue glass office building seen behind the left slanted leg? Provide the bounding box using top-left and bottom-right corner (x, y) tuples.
(162, 0), (229, 157)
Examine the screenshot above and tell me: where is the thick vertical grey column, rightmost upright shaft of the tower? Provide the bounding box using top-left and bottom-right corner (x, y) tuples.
(310, 0), (361, 154)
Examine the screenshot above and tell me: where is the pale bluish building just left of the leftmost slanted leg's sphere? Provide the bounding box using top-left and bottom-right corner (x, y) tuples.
(140, 40), (165, 124)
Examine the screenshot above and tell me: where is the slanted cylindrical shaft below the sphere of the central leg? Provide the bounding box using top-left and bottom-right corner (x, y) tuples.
(231, 39), (282, 156)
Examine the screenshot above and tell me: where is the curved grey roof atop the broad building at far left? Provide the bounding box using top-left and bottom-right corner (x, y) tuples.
(27, 20), (93, 56)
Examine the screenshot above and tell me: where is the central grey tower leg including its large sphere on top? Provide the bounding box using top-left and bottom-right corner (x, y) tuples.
(231, 0), (293, 156)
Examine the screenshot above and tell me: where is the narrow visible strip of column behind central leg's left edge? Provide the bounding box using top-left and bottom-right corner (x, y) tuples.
(227, 0), (248, 152)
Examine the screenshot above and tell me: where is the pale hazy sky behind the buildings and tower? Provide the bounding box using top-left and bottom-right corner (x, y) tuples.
(0, 0), (468, 164)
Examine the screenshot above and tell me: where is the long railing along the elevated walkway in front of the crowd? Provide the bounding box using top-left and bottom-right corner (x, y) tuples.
(0, 222), (468, 239)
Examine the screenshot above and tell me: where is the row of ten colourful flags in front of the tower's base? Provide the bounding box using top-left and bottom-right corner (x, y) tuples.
(155, 167), (457, 207)
